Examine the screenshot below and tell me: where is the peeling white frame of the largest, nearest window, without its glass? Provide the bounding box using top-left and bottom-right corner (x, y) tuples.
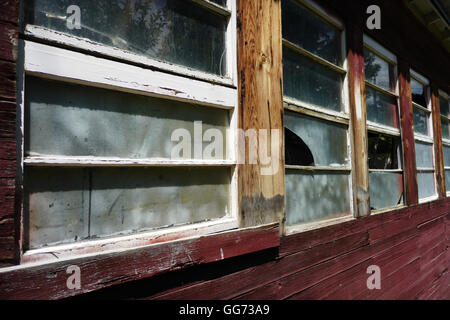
(17, 0), (239, 264)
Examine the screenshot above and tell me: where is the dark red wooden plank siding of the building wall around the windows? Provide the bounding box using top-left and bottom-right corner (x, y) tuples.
(0, 0), (450, 299)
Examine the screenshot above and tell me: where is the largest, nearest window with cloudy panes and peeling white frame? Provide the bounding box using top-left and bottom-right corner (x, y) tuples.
(22, 0), (237, 255)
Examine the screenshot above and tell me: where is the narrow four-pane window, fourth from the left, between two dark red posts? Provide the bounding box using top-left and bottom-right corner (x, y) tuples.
(411, 70), (437, 202)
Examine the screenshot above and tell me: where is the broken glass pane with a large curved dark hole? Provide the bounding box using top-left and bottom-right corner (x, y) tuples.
(284, 111), (349, 167)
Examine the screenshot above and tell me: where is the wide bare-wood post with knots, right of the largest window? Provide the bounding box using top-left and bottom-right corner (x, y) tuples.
(237, 0), (285, 229)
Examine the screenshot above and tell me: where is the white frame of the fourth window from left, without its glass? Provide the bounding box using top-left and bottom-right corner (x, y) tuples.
(410, 69), (438, 203)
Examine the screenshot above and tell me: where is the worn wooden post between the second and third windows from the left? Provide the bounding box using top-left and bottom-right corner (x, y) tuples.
(347, 25), (370, 217)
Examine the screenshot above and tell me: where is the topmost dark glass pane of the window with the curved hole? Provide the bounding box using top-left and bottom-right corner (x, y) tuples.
(281, 0), (342, 65)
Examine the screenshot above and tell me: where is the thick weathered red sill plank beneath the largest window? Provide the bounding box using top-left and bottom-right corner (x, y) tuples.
(0, 224), (279, 299)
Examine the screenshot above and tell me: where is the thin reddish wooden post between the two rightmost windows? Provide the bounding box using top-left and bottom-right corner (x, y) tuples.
(430, 84), (446, 198)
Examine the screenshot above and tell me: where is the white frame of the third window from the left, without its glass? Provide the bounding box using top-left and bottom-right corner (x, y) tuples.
(363, 34), (407, 214)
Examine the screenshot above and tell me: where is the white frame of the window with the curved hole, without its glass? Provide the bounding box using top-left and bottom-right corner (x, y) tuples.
(282, 0), (355, 235)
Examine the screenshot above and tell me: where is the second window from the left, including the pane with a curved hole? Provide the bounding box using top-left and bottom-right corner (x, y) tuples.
(282, 0), (353, 232)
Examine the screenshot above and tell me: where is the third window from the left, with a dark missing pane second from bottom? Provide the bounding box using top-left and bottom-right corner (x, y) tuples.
(364, 36), (404, 210)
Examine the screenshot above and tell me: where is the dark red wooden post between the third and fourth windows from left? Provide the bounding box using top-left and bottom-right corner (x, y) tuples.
(398, 59), (419, 205)
